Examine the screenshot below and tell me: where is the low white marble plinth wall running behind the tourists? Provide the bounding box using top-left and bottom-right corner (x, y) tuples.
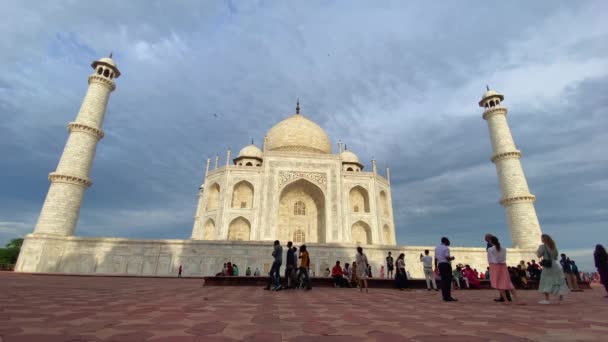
(16, 234), (535, 278)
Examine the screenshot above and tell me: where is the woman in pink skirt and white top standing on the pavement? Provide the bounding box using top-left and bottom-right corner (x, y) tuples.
(488, 236), (523, 304)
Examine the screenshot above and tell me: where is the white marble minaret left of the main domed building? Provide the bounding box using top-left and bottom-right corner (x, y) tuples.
(34, 54), (120, 236)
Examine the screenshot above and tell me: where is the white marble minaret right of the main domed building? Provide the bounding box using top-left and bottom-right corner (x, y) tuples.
(479, 87), (541, 249)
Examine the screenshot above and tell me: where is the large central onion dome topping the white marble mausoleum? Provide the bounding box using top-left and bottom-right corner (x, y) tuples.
(266, 114), (331, 153)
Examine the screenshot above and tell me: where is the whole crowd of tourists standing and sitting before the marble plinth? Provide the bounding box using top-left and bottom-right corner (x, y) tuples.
(203, 234), (608, 304)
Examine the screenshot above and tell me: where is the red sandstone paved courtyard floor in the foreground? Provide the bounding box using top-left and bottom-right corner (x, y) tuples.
(0, 272), (608, 342)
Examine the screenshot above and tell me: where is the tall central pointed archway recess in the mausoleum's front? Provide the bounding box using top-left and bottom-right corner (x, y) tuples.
(277, 179), (326, 243)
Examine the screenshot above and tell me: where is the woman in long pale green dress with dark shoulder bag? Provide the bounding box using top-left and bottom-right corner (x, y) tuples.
(536, 234), (570, 304)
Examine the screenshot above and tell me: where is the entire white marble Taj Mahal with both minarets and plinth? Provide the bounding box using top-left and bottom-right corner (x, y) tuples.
(15, 56), (541, 277)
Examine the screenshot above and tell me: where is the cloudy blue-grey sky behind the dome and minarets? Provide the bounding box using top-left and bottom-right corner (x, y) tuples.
(0, 1), (608, 268)
